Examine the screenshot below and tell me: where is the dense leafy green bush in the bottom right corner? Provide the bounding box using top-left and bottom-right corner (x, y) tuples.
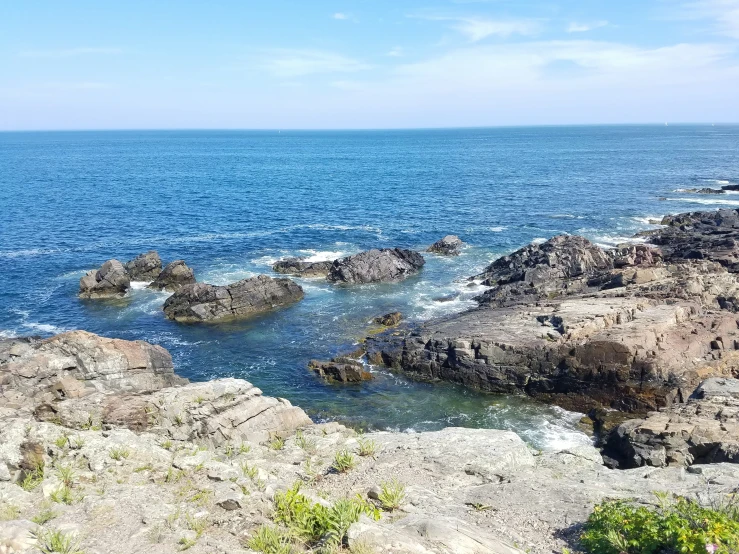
(581, 496), (739, 554)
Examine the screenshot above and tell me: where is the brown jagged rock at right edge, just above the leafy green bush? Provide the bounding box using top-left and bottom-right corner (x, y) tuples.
(605, 378), (739, 468)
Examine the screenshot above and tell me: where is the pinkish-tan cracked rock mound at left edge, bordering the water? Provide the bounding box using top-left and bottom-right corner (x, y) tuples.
(0, 331), (186, 409)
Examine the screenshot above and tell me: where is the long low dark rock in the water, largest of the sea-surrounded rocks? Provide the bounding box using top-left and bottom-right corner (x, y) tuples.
(164, 275), (303, 322)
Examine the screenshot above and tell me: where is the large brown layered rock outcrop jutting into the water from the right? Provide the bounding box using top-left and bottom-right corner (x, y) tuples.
(366, 222), (739, 413)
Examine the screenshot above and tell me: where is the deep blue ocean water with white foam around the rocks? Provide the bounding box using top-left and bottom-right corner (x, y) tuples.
(0, 126), (739, 448)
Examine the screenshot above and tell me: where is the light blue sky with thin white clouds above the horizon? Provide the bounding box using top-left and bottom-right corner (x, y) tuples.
(0, 0), (739, 130)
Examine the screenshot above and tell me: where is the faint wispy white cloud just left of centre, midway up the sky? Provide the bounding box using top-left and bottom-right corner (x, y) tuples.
(262, 50), (370, 78)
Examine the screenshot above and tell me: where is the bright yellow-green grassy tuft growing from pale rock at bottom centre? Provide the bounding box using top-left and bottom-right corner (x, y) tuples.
(275, 483), (380, 546)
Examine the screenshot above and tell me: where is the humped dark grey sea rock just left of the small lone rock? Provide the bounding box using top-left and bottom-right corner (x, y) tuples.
(327, 248), (426, 284)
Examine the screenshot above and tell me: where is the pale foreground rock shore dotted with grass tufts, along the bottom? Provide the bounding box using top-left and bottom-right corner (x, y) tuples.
(0, 331), (739, 554)
